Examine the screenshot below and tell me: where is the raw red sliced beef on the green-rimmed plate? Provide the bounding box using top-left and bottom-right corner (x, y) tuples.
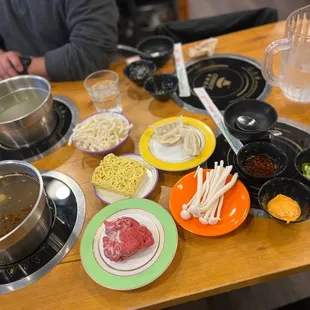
(103, 216), (154, 262)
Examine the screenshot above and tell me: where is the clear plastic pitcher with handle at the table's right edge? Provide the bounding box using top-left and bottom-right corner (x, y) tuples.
(263, 5), (310, 102)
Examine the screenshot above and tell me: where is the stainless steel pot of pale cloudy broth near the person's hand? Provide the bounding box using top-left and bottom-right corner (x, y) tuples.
(0, 75), (56, 149)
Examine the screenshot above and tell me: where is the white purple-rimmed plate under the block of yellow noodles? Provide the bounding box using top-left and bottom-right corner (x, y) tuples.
(94, 154), (158, 204)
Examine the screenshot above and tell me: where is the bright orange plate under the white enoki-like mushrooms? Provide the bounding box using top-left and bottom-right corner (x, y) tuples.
(170, 169), (250, 236)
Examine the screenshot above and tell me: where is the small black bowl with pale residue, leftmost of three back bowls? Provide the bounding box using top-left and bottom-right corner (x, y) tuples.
(124, 60), (156, 86)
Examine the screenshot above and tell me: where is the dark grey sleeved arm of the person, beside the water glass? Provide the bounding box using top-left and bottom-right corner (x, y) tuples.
(45, 0), (118, 81)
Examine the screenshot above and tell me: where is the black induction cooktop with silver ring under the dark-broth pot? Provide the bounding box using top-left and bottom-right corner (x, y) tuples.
(0, 171), (85, 294)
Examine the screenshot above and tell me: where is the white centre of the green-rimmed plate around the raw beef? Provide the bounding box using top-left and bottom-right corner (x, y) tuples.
(93, 209), (165, 276)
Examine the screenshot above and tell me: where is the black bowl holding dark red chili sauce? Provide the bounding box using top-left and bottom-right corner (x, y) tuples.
(236, 142), (288, 181)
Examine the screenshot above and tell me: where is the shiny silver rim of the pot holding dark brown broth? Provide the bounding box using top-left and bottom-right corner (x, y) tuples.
(0, 160), (45, 242)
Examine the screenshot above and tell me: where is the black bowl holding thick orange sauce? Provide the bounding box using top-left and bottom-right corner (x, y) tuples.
(258, 178), (310, 223)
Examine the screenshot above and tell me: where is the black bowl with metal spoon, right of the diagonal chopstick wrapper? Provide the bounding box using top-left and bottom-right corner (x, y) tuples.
(224, 99), (278, 141)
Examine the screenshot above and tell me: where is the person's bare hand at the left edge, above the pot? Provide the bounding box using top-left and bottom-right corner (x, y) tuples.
(0, 52), (24, 80)
